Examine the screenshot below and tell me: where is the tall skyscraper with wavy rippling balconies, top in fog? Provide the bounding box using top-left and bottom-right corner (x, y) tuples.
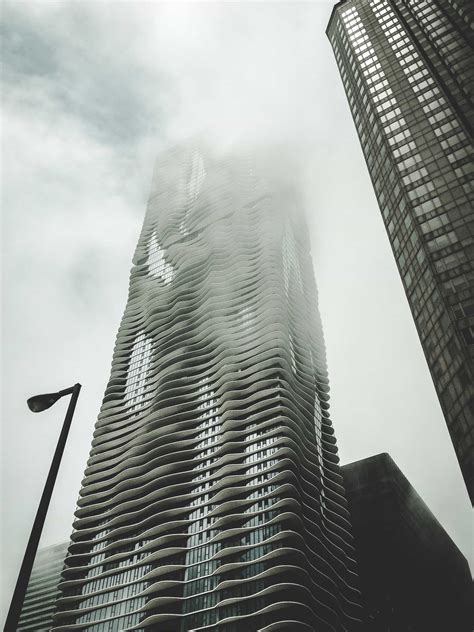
(54, 146), (359, 632)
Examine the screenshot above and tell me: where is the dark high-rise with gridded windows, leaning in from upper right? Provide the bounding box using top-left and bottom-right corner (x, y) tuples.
(327, 0), (474, 502)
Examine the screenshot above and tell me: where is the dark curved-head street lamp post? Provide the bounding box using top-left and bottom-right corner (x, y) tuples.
(4, 384), (81, 632)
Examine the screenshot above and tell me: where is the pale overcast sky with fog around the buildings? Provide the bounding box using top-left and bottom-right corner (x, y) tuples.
(2, 1), (471, 624)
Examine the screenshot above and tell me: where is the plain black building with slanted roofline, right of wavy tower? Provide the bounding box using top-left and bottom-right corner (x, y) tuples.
(341, 454), (473, 632)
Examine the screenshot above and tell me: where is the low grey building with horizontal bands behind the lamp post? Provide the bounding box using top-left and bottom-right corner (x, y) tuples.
(18, 542), (69, 632)
